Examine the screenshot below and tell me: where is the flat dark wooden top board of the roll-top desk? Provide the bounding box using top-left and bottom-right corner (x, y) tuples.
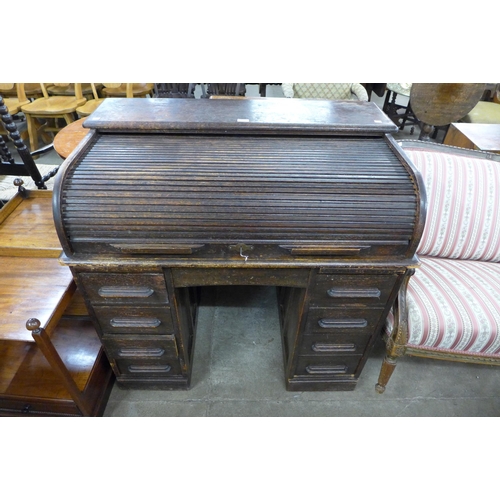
(84, 98), (397, 135)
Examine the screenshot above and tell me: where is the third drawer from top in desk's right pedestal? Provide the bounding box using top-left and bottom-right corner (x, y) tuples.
(299, 333), (371, 356)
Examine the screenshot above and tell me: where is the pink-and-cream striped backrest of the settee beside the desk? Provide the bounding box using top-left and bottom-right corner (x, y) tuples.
(405, 149), (500, 262)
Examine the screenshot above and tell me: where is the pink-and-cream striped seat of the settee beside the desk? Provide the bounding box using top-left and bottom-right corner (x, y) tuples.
(386, 257), (500, 358)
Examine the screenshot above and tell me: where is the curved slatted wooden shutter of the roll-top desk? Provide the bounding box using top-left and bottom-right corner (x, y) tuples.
(61, 133), (418, 251)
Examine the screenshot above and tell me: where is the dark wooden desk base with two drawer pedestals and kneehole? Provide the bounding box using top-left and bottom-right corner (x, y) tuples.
(73, 265), (406, 391)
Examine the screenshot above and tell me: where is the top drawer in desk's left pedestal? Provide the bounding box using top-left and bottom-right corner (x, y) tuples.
(77, 273), (168, 305)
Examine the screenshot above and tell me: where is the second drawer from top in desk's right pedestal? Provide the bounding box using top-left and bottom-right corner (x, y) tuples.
(305, 307), (384, 335)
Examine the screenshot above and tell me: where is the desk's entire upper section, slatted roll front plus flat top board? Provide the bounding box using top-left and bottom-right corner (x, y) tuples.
(54, 99), (424, 263)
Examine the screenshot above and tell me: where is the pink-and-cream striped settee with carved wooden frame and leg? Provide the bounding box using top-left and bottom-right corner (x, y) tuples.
(377, 141), (500, 392)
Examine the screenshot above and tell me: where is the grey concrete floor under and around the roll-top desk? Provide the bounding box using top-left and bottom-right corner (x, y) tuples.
(5, 86), (500, 417)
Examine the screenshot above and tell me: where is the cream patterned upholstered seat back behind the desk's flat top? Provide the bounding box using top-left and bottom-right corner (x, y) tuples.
(281, 83), (368, 101)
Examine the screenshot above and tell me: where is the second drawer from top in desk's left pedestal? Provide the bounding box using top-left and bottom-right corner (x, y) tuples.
(94, 306), (174, 335)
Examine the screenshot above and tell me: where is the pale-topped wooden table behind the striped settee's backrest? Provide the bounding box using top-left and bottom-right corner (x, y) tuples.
(444, 123), (500, 153)
